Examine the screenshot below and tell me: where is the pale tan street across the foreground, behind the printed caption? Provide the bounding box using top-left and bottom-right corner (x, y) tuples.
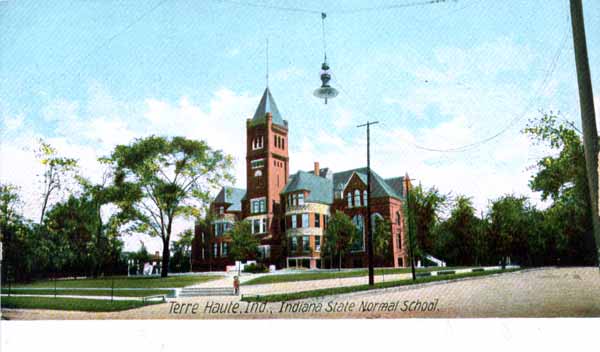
(3, 267), (600, 319)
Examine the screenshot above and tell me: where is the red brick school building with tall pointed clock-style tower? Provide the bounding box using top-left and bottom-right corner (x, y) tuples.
(192, 88), (408, 271)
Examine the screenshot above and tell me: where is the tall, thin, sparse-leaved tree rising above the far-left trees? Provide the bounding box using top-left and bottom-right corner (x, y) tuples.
(36, 139), (77, 224)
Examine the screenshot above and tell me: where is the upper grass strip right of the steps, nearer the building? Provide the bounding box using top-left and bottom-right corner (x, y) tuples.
(242, 267), (460, 285)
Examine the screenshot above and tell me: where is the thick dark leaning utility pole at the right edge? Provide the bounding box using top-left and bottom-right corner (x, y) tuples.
(571, 0), (600, 268)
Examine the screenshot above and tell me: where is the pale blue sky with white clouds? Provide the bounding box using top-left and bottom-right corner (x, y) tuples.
(0, 0), (600, 250)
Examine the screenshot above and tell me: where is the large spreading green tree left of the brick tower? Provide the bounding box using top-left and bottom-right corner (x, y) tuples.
(110, 136), (233, 277)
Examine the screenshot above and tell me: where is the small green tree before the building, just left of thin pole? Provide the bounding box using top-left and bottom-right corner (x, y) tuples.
(321, 211), (360, 269)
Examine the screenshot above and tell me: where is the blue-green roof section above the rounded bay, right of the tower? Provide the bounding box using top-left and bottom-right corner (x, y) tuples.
(281, 171), (333, 204)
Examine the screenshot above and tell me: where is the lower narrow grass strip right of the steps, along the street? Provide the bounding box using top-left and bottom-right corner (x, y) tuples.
(242, 269), (520, 302)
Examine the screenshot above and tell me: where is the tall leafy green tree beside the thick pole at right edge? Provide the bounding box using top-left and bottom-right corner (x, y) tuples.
(523, 112), (597, 265)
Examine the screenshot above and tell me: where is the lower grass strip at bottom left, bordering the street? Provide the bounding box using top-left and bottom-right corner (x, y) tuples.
(2, 296), (162, 312)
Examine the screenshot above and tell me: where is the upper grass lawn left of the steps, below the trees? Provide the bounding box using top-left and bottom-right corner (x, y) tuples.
(14, 275), (221, 288)
